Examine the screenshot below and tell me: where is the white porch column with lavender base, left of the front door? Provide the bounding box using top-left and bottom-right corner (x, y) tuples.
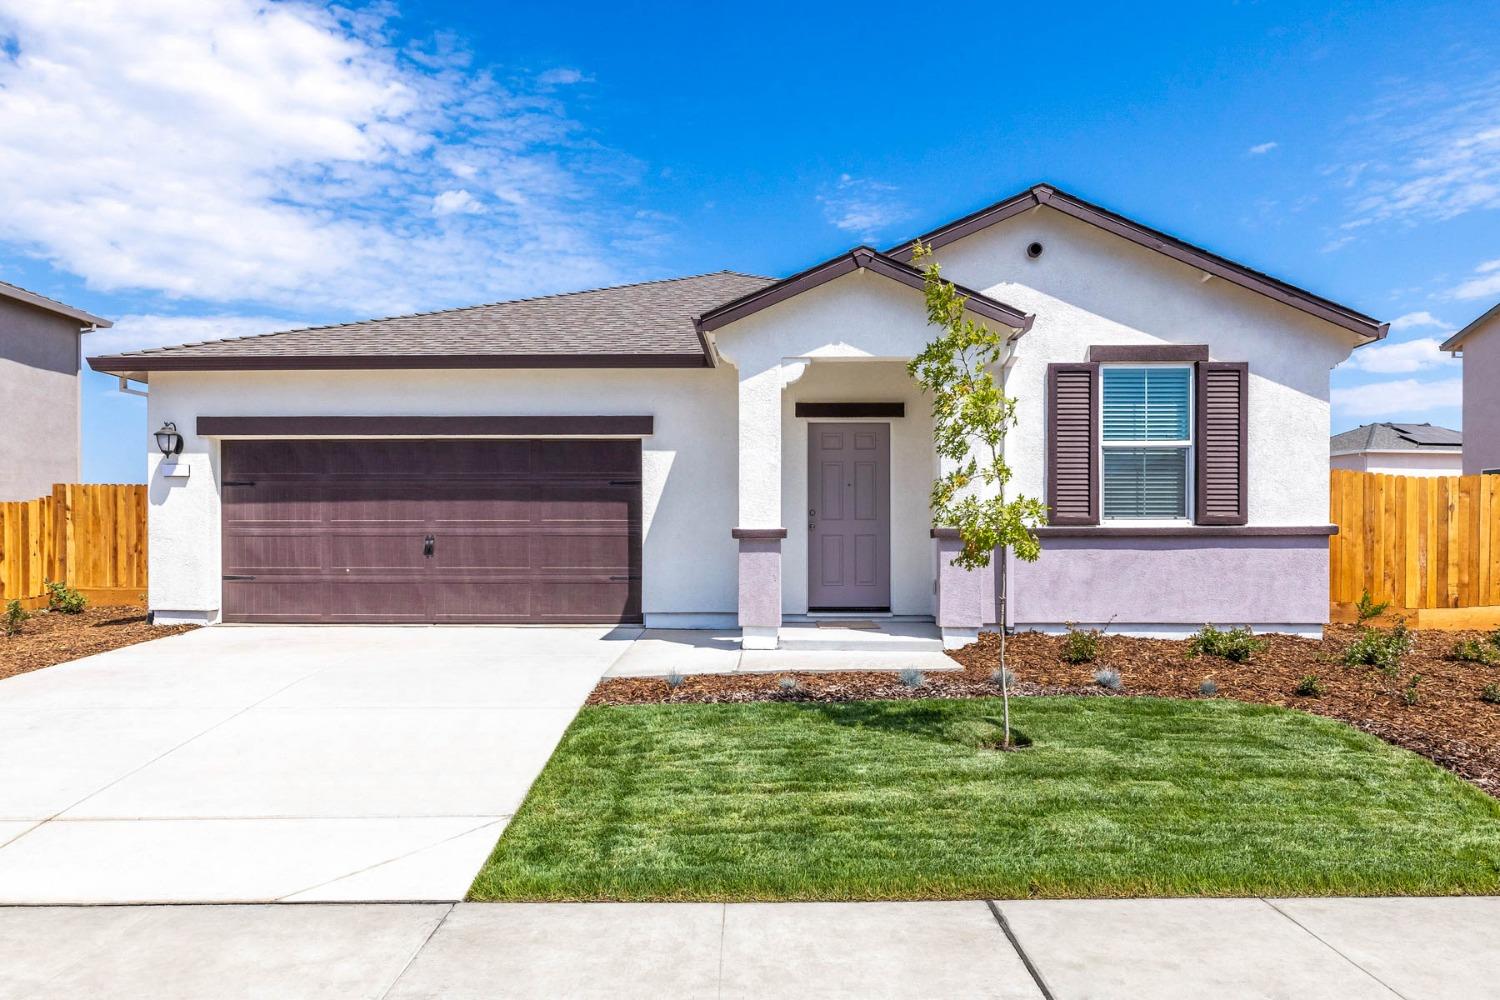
(732, 361), (806, 649)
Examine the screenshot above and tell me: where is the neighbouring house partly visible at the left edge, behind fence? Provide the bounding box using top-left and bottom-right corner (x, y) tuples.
(0, 282), (110, 501)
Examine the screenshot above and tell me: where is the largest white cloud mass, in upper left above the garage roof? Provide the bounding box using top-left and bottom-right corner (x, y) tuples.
(0, 0), (651, 315)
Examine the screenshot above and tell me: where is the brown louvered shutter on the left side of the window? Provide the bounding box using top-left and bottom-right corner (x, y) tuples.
(1047, 364), (1100, 525)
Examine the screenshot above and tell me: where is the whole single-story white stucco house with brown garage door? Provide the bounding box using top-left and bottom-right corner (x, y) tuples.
(90, 186), (1386, 648)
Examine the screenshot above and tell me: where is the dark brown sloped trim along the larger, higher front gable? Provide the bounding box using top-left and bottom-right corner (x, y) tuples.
(887, 184), (1391, 342)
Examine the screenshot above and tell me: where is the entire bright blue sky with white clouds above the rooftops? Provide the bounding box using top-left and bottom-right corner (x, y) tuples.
(0, 0), (1500, 481)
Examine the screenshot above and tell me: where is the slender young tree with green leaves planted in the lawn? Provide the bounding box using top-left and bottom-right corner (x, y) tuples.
(906, 243), (1047, 748)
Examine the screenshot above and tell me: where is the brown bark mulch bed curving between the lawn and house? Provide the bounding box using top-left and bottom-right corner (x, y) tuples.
(588, 625), (1500, 796)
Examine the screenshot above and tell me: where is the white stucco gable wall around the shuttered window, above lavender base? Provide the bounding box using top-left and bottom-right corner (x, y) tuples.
(938, 207), (1356, 526)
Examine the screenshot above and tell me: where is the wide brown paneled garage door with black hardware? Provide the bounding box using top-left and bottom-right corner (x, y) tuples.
(222, 439), (641, 622)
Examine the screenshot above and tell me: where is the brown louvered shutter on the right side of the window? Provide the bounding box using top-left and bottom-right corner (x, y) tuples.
(1193, 361), (1250, 525)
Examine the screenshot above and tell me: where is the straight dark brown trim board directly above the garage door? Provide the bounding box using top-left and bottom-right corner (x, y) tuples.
(197, 415), (656, 438)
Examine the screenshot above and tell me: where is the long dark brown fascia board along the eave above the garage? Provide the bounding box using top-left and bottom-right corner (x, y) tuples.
(89, 354), (710, 375)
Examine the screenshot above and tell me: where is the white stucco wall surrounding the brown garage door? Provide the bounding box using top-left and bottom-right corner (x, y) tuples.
(143, 369), (737, 621)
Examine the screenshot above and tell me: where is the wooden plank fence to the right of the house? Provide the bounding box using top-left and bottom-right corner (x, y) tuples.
(1329, 469), (1500, 627)
